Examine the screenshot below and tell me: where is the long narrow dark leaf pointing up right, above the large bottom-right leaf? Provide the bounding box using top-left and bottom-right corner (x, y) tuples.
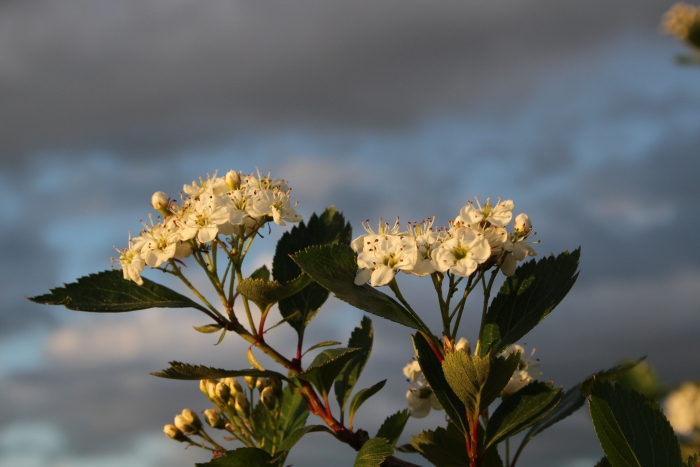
(516, 357), (646, 462)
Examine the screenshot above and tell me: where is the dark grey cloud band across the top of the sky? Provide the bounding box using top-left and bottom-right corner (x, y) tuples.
(0, 0), (667, 168)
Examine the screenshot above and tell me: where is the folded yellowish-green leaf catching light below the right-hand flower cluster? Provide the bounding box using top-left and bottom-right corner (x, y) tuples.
(442, 352), (520, 414)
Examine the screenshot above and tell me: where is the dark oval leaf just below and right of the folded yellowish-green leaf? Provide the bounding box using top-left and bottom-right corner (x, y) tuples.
(484, 381), (562, 448)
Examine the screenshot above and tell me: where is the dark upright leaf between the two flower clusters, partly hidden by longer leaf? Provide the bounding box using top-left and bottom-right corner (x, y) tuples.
(272, 206), (352, 334)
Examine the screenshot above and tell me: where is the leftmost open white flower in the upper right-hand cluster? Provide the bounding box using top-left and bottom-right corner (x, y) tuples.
(355, 235), (418, 287)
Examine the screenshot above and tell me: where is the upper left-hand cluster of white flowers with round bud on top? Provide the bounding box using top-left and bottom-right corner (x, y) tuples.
(117, 170), (301, 285)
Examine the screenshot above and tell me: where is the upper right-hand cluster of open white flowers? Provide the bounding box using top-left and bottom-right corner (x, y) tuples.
(352, 198), (536, 287)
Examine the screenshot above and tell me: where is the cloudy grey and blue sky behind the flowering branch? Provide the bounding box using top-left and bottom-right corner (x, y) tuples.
(0, 0), (700, 467)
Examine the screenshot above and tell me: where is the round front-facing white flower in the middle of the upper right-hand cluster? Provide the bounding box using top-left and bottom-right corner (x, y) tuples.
(432, 227), (491, 277)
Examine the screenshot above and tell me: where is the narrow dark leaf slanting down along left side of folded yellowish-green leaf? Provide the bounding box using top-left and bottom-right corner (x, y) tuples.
(413, 333), (469, 434)
